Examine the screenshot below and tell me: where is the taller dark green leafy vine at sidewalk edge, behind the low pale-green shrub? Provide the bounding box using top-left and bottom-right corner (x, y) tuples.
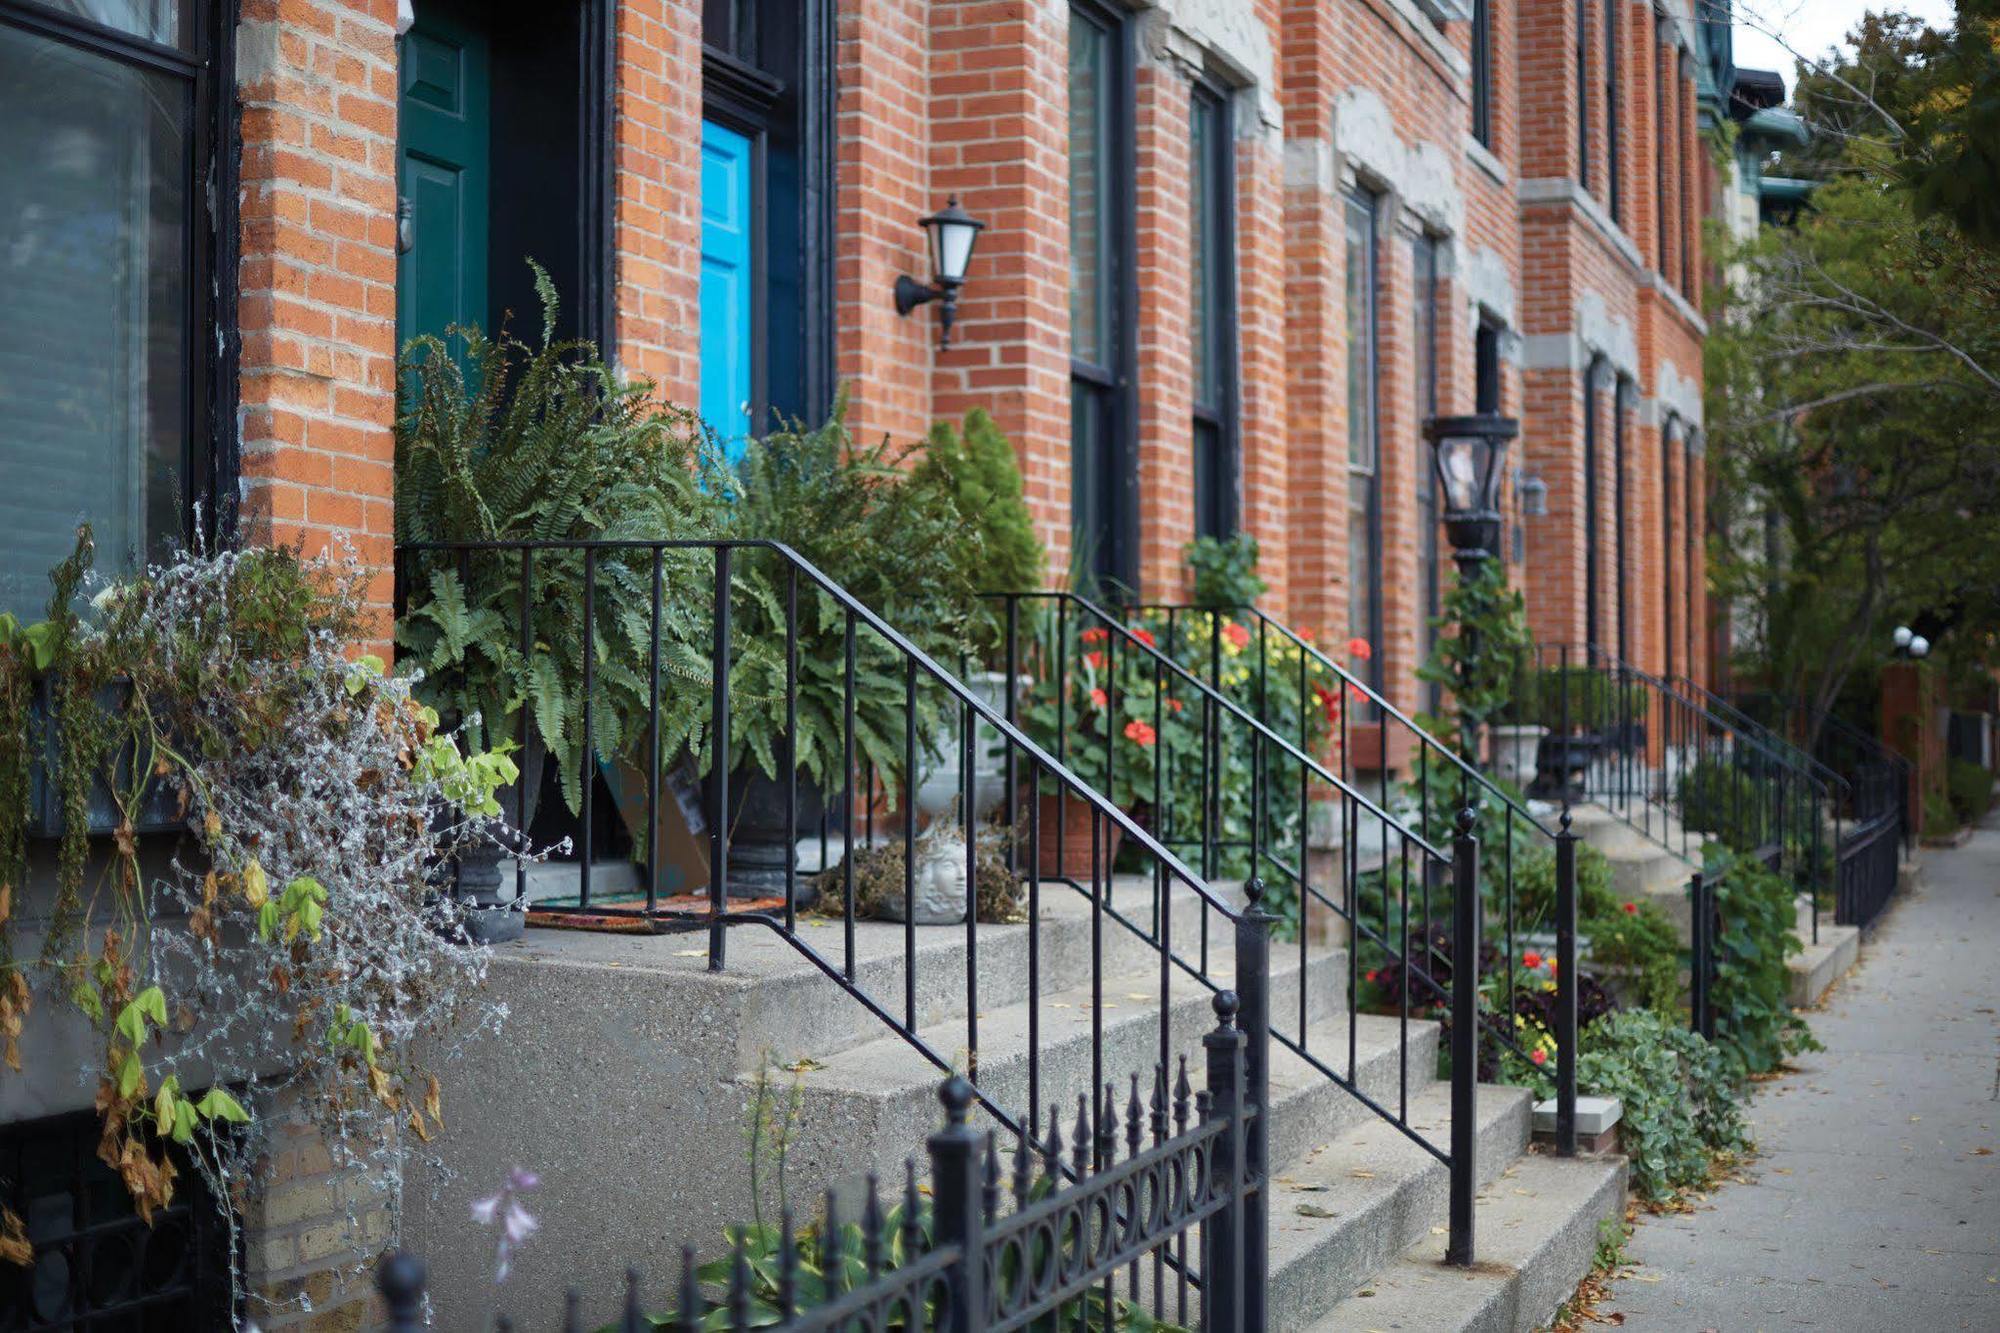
(1702, 847), (1820, 1081)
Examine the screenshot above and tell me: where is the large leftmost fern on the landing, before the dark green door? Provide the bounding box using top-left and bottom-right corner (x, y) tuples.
(396, 266), (756, 811)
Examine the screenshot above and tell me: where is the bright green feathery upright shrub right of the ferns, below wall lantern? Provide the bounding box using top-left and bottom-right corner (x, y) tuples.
(912, 408), (1044, 660)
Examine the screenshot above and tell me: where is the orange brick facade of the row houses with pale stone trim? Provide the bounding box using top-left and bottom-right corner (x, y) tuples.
(238, 0), (1708, 705)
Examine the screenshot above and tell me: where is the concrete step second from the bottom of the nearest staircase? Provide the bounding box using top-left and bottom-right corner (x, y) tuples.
(1266, 1081), (1530, 1329)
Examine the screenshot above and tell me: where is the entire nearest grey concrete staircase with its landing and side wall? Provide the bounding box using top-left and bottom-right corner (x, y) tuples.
(404, 883), (1624, 1329)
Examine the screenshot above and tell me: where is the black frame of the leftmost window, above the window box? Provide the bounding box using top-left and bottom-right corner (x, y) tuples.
(0, 0), (242, 558)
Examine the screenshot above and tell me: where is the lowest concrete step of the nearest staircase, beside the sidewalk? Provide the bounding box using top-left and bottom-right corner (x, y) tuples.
(1312, 1153), (1624, 1333)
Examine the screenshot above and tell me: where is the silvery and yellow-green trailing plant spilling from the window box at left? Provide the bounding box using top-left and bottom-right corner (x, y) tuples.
(0, 528), (514, 1296)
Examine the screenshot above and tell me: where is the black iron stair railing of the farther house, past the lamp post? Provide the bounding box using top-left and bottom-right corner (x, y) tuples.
(1508, 644), (1836, 941)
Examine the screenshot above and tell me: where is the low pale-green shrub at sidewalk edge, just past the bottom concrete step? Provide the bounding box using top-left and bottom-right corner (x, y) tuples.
(1576, 1009), (1746, 1203)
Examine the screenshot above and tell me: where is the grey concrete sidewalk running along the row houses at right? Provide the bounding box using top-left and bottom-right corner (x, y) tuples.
(1600, 817), (2000, 1333)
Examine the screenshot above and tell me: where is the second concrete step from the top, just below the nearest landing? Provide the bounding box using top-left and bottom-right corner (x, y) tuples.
(772, 951), (1352, 1189)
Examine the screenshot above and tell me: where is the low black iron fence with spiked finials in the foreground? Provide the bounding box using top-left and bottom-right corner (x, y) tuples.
(376, 992), (1270, 1333)
